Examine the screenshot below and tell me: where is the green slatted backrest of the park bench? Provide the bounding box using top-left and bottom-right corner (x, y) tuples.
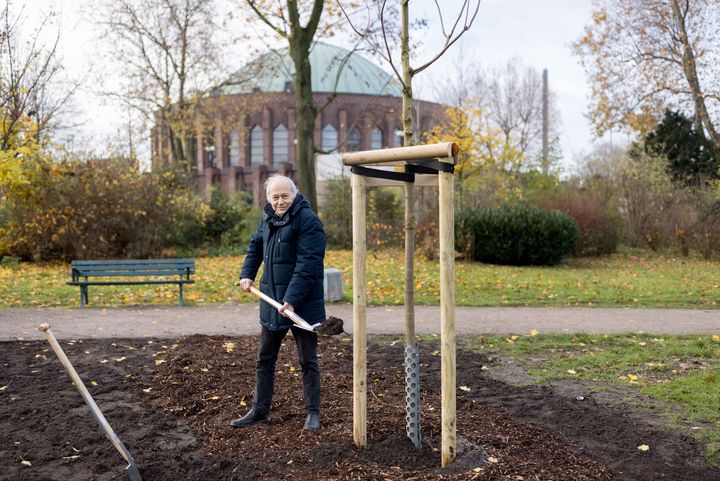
(70, 259), (195, 280)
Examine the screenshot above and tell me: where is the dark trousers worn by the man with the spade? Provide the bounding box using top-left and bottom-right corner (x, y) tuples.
(253, 326), (320, 415)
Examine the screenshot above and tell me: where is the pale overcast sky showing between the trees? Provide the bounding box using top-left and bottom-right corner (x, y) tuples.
(27, 0), (616, 170)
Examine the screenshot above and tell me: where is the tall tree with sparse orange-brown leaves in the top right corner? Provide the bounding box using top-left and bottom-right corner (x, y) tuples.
(573, 0), (720, 147)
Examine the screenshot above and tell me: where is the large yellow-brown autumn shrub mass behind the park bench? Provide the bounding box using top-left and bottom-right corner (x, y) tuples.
(0, 159), (202, 260)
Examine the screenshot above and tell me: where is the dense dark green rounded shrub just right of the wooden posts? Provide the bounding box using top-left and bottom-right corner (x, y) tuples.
(456, 204), (579, 265)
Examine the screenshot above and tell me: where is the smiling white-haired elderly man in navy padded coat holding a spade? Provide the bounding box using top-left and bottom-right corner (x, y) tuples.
(230, 175), (326, 429)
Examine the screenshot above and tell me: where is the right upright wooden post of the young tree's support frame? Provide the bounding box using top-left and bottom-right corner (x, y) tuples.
(438, 157), (457, 467)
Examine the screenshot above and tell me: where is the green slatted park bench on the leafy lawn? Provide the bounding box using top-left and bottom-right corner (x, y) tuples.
(66, 259), (195, 307)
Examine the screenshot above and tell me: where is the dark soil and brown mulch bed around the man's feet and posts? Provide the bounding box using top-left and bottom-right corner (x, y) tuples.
(0, 335), (720, 481)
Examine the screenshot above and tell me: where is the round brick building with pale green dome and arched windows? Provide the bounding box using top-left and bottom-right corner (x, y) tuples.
(152, 42), (445, 206)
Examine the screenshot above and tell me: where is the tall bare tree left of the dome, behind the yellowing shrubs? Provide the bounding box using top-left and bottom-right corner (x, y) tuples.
(98, 0), (220, 170)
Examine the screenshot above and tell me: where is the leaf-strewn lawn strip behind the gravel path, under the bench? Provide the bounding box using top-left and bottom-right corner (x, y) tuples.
(0, 250), (720, 308)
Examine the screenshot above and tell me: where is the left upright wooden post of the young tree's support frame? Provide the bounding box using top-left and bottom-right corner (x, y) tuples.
(352, 174), (367, 448)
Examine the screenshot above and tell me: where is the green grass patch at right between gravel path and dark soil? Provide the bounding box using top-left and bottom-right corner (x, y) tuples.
(464, 334), (720, 466)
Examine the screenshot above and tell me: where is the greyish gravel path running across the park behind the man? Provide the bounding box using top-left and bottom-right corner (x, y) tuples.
(0, 304), (720, 341)
